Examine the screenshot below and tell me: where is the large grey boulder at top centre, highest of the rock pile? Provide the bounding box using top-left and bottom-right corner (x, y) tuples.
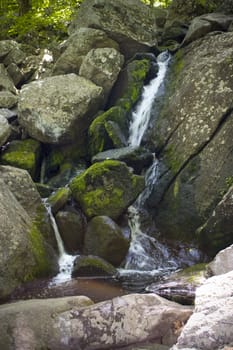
(69, 0), (165, 57)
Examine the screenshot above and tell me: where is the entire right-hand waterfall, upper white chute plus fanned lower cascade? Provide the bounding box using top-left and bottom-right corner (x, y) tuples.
(119, 52), (177, 281)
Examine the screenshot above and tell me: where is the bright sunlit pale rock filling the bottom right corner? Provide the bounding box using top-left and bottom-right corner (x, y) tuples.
(172, 271), (233, 350)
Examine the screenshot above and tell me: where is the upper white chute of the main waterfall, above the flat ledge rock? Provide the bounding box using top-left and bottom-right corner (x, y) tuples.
(128, 51), (170, 146)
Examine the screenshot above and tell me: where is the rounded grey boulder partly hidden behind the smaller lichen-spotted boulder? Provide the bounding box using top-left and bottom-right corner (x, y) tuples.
(53, 28), (119, 75)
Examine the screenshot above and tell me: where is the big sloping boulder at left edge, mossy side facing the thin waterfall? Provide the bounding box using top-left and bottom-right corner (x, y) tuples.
(0, 179), (53, 298)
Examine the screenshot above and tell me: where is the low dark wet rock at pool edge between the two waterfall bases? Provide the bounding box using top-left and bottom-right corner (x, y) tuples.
(72, 255), (117, 277)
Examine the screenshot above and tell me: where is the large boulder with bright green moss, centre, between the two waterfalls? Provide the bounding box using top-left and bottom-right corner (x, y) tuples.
(70, 160), (144, 219)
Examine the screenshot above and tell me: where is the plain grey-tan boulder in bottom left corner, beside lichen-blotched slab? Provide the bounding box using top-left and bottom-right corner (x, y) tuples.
(0, 296), (92, 350)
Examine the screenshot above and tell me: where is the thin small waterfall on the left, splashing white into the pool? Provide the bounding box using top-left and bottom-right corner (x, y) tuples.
(45, 203), (77, 285)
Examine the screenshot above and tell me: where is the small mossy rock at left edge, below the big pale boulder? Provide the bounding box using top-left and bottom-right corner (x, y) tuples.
(1, 139), (41, 180)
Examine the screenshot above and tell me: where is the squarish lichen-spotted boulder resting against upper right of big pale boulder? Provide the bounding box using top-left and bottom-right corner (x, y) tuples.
(79, 48), (124, 100)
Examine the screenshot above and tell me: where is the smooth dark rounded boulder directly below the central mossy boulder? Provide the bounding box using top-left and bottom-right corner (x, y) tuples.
(84, 216), (129, 266)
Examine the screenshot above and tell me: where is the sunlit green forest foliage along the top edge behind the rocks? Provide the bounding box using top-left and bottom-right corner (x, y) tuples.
(0, 0), (171, 47)
